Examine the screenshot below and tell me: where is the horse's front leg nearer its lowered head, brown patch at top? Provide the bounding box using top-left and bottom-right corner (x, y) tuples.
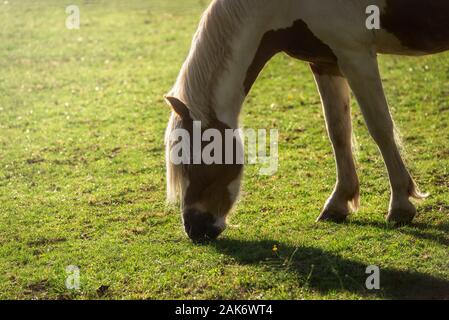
(311, 64), (359, 222)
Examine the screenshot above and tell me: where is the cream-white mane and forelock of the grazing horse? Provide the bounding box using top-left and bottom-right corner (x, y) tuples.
(165, 0), (260, 203)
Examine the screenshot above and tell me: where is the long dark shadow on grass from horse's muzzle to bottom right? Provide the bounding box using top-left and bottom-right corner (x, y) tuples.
(213, 238), (449, 299)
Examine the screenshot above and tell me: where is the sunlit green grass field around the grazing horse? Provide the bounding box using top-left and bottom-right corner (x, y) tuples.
(0, 0), (449, 299)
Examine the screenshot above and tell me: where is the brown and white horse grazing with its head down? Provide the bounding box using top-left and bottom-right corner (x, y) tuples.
(166, 0), (449, 240)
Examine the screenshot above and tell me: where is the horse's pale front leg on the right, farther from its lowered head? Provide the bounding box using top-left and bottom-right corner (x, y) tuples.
(337, 51), (424, 224)
